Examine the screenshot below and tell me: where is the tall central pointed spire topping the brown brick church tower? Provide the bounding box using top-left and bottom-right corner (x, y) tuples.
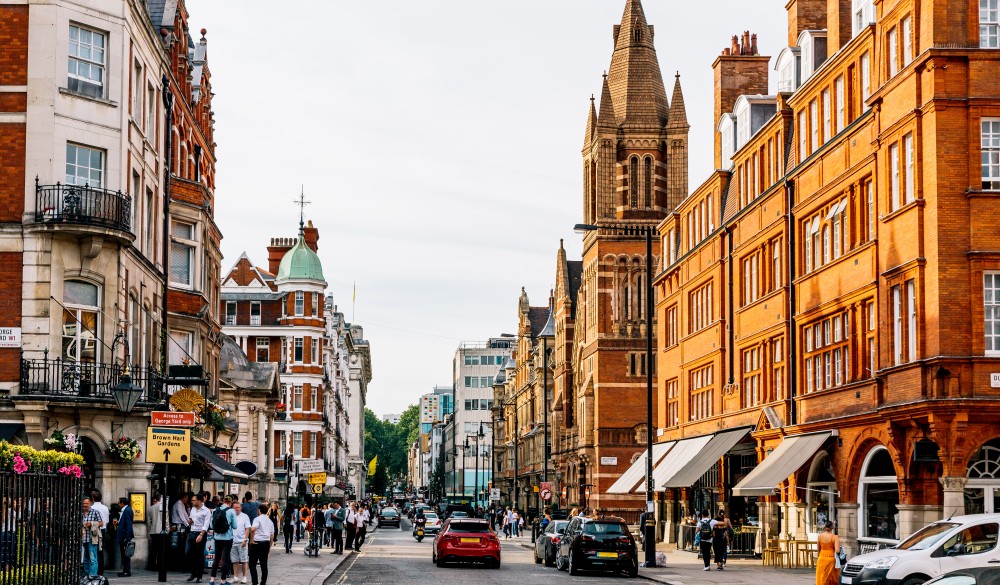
(601, 0), (668, 127)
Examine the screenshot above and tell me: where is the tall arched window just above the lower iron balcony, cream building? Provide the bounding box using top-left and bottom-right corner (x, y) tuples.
(62, 280), (101, 363)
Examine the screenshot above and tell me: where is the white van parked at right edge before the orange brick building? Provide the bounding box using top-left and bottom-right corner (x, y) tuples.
(840, 514), (1000, 585)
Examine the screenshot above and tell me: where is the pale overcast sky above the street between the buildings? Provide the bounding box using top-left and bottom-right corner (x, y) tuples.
(195, 0), (787, 414)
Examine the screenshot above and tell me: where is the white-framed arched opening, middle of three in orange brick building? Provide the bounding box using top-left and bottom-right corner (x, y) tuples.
(858, 445), (899, 540)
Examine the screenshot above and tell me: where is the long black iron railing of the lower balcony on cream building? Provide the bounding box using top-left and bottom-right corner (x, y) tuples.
(19, 351), (163, 405)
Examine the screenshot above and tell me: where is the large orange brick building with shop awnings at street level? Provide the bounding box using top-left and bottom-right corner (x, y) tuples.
(632, 0), (1000, 551)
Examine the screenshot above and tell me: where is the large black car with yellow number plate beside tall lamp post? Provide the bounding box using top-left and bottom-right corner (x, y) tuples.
(556, 517), (639, 577)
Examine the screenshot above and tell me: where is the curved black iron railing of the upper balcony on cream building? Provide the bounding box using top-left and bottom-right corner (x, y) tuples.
(35, 177), (132, 232)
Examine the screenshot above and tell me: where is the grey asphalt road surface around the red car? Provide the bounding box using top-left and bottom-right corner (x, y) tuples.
(332, 525), (636, 585)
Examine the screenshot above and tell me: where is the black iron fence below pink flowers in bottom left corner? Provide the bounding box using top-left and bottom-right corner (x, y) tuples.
(0, 472), (83, 585)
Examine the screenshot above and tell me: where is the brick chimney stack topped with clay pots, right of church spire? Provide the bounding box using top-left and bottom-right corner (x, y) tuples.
(712, 32), (764, 168)
